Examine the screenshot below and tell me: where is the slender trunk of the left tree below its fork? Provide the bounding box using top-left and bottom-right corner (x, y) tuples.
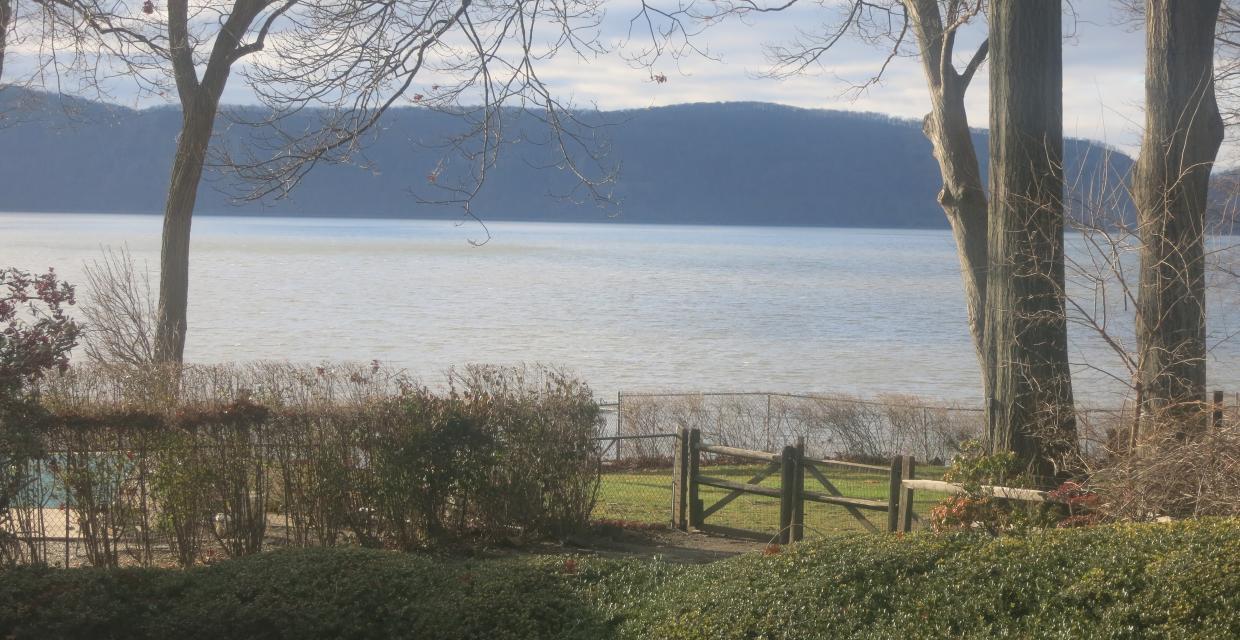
(155, 99), (216, 362)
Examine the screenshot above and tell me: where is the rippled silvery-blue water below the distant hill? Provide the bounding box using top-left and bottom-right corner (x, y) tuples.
(0, 213), (1240, 402)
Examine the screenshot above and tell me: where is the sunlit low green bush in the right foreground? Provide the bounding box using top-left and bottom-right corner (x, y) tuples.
(595, 520), (1240, 639)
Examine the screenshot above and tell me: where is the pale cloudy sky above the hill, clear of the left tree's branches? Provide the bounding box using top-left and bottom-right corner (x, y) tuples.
(4, 0), (1160, 158)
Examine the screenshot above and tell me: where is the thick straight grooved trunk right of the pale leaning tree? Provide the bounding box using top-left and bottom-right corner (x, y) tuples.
(985, 0), (1076, 482)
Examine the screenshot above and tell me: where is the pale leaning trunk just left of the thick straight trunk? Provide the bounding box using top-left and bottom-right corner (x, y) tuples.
(905, 0), (990, 398)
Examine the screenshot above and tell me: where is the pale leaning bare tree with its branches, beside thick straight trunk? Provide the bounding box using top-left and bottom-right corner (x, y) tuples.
(634, 0), (990, 397)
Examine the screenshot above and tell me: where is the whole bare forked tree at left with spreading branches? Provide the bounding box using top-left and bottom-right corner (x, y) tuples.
(5, 0), (606, 362)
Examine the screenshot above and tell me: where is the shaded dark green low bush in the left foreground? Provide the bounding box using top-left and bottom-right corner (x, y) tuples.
(0, 548), (609, 640)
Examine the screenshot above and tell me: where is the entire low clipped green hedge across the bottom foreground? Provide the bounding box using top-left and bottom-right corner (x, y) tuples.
(0, 518), (1240, 639)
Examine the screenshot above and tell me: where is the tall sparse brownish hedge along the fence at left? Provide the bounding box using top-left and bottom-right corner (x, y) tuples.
(0, 363), (603, 566)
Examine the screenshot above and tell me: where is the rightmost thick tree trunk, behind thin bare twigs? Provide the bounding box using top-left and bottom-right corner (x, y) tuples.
(1132, 0), (1223, 424)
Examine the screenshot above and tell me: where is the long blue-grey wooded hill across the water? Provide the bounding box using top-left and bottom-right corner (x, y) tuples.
(0, 88), (1131, 228)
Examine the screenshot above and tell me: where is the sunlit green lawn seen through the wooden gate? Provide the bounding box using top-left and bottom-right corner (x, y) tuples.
(594, 464), (944, 537)
